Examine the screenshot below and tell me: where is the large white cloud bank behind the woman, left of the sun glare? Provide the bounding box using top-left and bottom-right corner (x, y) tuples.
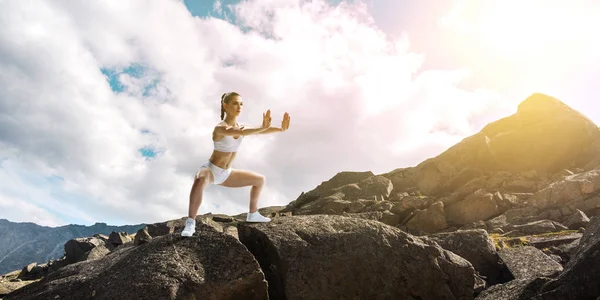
(0, 0), (515, 224)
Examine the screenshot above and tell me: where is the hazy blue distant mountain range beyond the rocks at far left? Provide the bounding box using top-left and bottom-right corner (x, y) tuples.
(0, 219), (145, 274)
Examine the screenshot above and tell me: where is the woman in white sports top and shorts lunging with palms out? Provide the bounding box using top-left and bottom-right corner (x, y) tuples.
(181, 92), (290, 236)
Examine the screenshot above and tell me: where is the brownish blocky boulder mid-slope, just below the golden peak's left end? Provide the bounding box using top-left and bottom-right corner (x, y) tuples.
(446, 190), (500, 225)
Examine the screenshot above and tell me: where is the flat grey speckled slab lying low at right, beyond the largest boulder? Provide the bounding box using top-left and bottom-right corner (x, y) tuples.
(498, 246), (563, 279)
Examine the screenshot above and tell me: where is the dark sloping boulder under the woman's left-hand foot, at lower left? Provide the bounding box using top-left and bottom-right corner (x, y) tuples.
(4, 225), (267, 300)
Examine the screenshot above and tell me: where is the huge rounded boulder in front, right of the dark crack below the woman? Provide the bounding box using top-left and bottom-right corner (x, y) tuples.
(238, 215), (475, 299)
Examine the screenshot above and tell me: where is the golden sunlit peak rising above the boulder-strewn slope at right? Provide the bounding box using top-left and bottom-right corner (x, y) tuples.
(402, 94), (600, 195)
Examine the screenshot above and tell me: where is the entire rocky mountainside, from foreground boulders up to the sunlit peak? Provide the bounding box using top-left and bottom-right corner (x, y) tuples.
(0, 94), (600, 300)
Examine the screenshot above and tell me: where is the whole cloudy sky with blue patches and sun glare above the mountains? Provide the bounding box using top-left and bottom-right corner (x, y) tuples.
(0, 0), (600, 226)
